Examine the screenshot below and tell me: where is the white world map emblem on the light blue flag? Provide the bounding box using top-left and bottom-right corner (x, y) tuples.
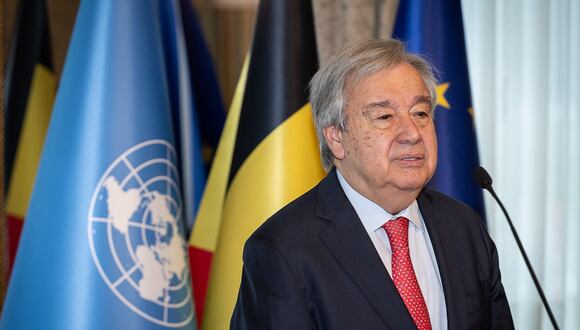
(88, 140), (193, 327)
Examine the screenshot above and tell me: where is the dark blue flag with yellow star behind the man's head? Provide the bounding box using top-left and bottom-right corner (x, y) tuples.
(393, 0), (485, 218)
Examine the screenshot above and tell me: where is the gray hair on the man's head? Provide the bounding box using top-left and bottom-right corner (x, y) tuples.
(310, 39), (437, 171)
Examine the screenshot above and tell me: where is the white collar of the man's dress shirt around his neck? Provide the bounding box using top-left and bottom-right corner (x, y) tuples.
(336, 169), (425, 233)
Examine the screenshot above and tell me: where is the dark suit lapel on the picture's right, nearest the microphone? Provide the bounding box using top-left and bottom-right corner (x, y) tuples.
(417, 191), (467, 329)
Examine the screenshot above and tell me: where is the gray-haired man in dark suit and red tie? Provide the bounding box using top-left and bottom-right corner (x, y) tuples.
(231, 40), (513, 329)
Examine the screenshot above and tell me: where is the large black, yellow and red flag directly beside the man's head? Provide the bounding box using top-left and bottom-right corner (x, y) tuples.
(190, 0), (324, 329)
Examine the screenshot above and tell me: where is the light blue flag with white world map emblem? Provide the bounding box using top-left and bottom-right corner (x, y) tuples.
(0, 0), (195, 330)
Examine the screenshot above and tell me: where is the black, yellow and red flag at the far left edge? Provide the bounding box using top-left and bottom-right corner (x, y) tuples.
(4, 0), (56, 278)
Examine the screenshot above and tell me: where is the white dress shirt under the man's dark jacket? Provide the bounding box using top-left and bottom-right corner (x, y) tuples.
(336, 170), (447, 329)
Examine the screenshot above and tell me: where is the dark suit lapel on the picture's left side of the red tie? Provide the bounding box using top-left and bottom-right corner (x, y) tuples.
(317, 171), (414, 329)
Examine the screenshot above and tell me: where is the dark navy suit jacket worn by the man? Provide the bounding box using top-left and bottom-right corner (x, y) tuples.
(231, 171), (513, 329)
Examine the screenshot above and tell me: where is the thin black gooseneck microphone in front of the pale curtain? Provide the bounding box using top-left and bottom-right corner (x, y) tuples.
(473, 166), (560, 330)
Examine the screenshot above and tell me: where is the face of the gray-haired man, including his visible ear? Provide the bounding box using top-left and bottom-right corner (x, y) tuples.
(325, 63), (437, 199)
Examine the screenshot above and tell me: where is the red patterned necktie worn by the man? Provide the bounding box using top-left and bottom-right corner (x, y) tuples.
(383, 217), (431, 330)
